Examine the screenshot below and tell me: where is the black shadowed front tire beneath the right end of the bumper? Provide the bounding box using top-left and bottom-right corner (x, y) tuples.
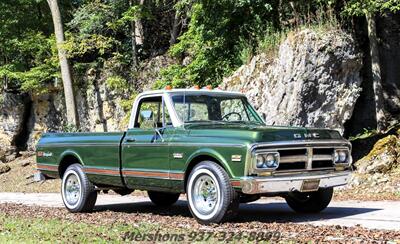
(285, 187), (333, 213)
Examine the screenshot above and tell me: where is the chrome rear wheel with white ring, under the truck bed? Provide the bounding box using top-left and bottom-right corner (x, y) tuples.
(62, 171), (82, 209)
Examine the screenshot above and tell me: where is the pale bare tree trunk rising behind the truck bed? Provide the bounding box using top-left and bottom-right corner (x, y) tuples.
(47, 0), (79, 127)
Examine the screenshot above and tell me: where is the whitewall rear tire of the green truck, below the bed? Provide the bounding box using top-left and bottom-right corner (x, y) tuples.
(61, 164), (97, 213)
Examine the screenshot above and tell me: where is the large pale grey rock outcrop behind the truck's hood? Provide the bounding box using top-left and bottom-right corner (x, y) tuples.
(221, 30), (362, 132)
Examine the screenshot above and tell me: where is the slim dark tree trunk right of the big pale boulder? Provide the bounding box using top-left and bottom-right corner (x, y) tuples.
(366, 13), (386, 132)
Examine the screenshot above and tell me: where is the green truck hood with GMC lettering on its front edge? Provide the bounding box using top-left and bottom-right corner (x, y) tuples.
(185, 123), (343, 143)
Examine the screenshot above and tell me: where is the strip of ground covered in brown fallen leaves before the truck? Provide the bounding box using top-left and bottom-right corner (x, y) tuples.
(0, 204), (400, 243)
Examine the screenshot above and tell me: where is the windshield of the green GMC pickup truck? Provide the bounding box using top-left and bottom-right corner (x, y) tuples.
(172, 94), (263, 124)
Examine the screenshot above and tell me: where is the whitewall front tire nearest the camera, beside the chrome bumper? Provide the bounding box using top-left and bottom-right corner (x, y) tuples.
(186, 161), (239, 224)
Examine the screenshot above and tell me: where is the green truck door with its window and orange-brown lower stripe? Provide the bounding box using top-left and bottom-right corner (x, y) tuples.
(121, 95), (173, 190)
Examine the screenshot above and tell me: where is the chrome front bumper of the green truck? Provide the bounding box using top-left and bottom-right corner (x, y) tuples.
(240, 171), (351, 194)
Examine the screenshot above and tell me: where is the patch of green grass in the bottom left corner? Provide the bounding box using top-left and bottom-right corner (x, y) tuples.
(0, 214), (169, 243)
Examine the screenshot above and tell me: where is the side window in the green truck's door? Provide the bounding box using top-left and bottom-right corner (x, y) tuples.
(135, 96), (163, 129)
